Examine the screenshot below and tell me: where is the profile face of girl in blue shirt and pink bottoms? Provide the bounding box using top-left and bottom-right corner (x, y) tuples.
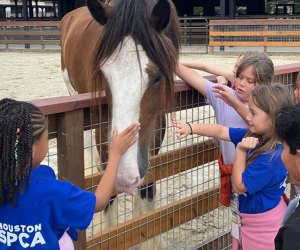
(247, 98), (273, 136)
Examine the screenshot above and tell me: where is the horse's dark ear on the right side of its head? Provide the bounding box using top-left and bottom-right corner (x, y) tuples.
(150, 0), (171, 32)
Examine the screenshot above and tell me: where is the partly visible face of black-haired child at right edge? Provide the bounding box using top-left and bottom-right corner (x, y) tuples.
(281, 142), (300, 186)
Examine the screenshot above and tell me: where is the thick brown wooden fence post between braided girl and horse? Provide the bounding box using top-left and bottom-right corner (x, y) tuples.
(57, 109), (86, 250)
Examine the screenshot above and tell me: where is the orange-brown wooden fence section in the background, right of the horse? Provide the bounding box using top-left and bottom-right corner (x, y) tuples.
(209, 19), (300, 52)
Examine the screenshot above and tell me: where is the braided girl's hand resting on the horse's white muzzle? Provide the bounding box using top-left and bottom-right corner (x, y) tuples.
(110, 123), (140, 155)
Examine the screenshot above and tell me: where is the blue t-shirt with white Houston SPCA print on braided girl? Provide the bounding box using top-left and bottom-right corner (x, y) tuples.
(0, 165), (96, 250)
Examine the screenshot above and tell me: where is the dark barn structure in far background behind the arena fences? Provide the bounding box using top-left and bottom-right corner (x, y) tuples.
(0, 0), (300, 20)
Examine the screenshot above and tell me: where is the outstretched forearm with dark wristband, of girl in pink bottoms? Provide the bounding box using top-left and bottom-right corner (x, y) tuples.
(172, 120), (230, 141)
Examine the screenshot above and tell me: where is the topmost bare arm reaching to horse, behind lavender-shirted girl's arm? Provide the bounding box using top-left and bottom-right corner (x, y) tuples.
(181, 61), (235, 82)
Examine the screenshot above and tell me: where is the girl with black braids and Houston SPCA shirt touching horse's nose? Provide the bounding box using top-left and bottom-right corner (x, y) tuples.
(0, 99), (140, 250)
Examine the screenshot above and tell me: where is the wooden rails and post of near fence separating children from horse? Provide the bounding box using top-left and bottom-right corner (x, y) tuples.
(33, 63), (300, 250)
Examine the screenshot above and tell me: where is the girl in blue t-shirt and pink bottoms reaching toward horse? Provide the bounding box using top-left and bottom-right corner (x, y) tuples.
(174, 85), (293, 250)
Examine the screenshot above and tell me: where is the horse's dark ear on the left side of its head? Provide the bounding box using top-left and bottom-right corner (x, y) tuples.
(86, 0), (112, 25)
